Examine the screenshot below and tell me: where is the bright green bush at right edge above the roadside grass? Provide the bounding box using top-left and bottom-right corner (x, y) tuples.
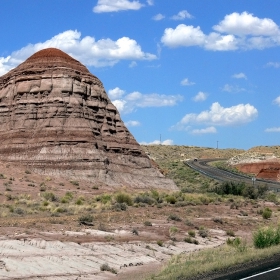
(253, 226), (280, 248)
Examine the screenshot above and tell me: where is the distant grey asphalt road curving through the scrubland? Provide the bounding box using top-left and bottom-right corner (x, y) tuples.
(184, 159), (280, 192)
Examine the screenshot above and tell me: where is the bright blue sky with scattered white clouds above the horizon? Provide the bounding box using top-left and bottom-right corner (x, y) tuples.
(0, 0), (280, 149)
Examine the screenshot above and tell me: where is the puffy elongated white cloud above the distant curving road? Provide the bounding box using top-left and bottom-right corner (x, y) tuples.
(174, 102), (258, 129)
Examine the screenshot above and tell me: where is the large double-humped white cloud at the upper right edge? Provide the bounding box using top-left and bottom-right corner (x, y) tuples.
(161, 12), (280, 51)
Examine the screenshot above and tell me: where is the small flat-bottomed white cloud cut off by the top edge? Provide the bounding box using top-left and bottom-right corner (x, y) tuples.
(93, 0), (144, 13)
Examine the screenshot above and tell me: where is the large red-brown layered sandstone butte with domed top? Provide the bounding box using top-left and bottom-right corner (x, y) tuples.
(0, 48), (176, 189)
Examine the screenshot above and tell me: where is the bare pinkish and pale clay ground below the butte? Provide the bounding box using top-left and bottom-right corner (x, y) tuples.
(0, 159), (278, 280)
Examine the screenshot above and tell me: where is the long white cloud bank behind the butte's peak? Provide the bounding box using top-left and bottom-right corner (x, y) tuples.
(0, 30), (157, 74)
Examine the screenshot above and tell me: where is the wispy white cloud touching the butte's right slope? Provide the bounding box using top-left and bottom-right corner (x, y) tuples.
(108, 87), (183, 114)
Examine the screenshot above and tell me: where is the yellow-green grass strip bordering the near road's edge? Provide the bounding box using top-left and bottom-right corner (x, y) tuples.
(146, 242), (280, 280)
